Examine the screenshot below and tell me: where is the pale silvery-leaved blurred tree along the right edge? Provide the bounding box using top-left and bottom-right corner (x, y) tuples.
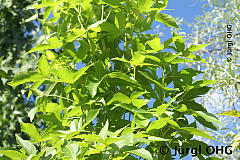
(167, 0), (240, 159)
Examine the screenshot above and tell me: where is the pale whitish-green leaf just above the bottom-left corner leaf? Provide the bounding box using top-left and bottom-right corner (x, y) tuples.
(15, 134), (37, 156)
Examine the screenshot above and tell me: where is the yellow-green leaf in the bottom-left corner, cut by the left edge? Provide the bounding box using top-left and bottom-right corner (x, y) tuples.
(0, 148), (27, 160)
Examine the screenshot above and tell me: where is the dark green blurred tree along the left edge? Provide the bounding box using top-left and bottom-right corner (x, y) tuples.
(0, 0), (40, 147)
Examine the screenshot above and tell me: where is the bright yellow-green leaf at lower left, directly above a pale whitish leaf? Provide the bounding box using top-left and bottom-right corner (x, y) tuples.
(20, 122), (41, 142)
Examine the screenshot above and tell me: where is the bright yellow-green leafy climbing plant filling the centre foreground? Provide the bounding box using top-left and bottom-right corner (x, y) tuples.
(0, 0), (222, 160)
